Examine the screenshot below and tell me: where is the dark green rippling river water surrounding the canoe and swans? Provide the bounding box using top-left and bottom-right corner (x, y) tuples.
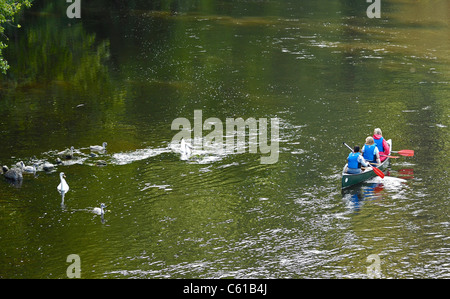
(0, 0), (450, 278)
